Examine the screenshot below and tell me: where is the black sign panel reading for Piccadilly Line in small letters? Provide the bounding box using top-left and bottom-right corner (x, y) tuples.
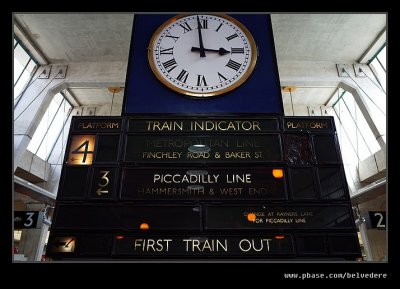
(206, 204), (354, 230)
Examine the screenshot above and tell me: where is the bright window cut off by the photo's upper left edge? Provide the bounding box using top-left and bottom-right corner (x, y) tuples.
(14, 38), (37, 103)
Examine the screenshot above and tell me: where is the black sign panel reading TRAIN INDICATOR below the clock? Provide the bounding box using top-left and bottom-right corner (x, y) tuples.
(128, 118), (278, 134)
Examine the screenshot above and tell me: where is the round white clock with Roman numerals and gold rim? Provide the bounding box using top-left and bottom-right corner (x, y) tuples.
(148, 14), (257, 98)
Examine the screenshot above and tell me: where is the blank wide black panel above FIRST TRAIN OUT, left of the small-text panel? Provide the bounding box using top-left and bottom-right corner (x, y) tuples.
(52, 204), (200, 231)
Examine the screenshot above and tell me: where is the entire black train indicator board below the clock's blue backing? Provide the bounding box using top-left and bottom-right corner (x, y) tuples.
(47, 115), (360, 260)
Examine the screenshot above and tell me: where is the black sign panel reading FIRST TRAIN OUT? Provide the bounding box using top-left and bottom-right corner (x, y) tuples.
(115, 234), (294, 257)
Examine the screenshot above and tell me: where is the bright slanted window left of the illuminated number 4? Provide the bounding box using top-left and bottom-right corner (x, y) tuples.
(28, 93), (72, 160)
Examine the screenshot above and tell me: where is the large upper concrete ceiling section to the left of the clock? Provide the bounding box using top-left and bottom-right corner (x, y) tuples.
(15, 13), (133, 63)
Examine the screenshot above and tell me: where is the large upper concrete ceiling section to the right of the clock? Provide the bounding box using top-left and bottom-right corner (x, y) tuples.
(271, 14), (386, 62)
